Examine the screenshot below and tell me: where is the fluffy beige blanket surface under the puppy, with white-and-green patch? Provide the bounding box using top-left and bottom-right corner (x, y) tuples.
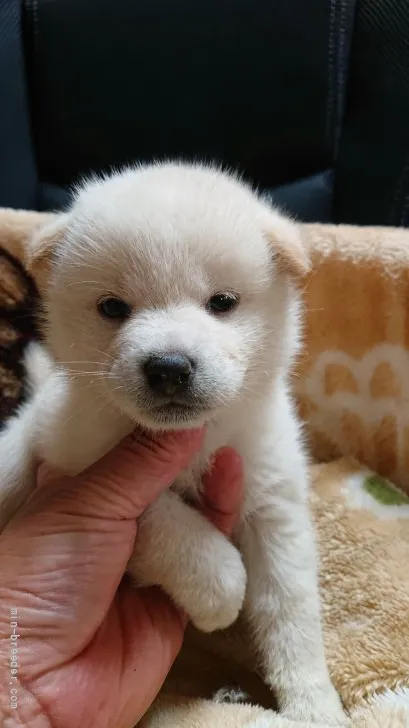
(140, 458), (409, 728)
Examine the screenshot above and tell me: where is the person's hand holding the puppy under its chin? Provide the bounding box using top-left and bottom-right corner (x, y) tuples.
(0, 431), (242, 728)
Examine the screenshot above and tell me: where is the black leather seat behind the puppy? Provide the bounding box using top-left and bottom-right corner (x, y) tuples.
(0, 0), (409, 225)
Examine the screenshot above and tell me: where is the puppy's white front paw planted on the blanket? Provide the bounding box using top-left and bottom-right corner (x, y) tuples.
(282, 683), (350, 728)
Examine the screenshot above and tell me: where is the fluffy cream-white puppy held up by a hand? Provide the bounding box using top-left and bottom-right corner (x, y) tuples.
(0, 164), (346, 725)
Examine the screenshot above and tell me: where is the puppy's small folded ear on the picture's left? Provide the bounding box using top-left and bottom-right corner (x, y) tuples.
(25, 213), (69, 291)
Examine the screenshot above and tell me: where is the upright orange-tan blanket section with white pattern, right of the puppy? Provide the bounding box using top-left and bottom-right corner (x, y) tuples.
(295, 225), (409, 490)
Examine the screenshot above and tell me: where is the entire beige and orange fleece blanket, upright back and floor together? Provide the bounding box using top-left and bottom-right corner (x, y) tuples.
(0, 210), (409, 728)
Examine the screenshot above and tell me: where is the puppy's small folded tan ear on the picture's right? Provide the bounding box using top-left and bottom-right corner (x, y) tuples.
(265, 211), (311, 280)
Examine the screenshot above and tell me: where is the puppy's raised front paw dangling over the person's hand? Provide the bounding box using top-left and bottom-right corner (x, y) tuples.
(184, 539), (247, 632)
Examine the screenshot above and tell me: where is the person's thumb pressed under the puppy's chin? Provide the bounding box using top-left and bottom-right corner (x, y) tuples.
(33, 429), (204, 520)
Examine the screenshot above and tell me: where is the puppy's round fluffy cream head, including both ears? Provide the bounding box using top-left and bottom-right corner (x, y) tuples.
(28, 165), (306, 429)
